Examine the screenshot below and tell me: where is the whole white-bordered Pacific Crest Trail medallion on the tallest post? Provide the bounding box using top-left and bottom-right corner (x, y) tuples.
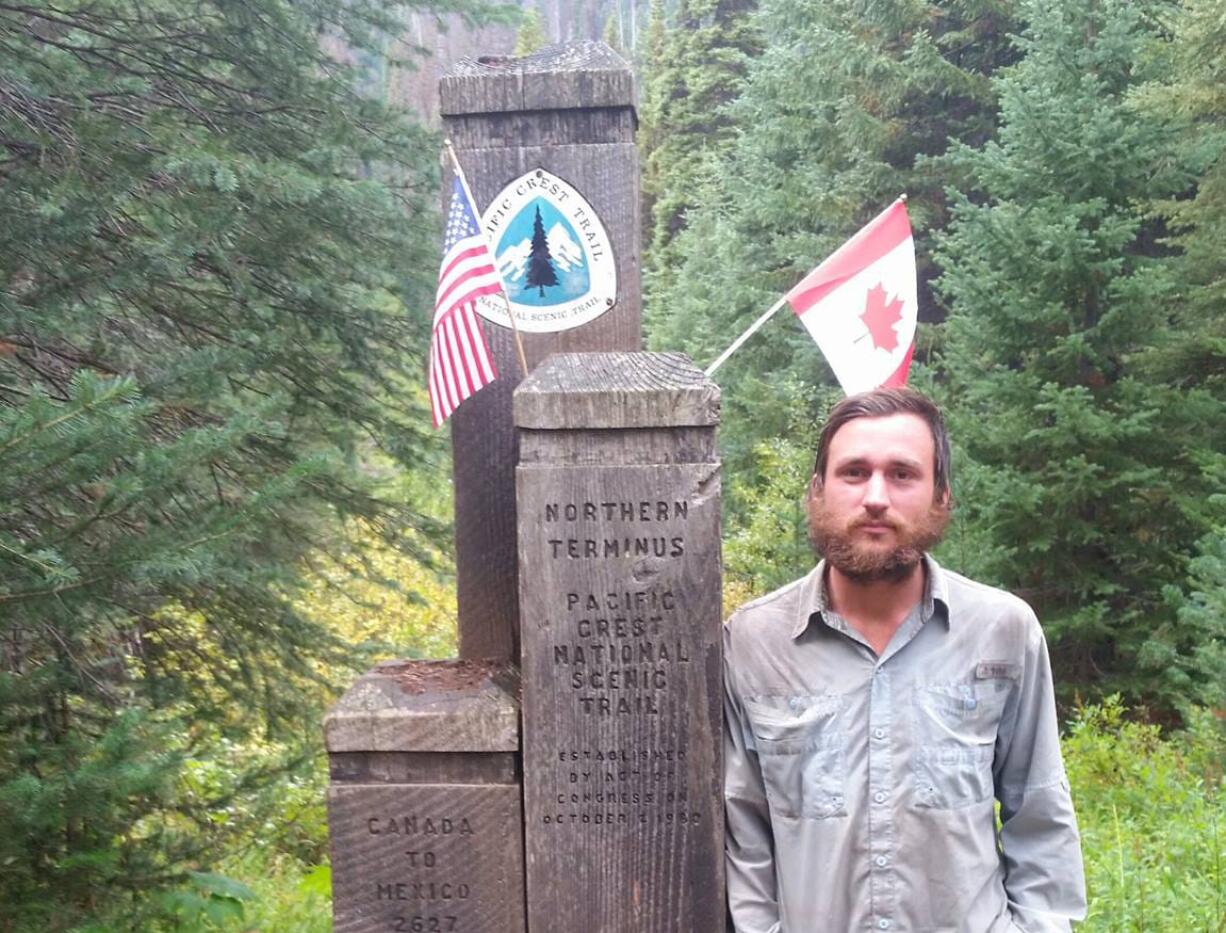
(477, 168), (617, 333)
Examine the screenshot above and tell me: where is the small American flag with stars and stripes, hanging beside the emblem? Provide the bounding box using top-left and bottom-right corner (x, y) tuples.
(429, 178), (503, 428)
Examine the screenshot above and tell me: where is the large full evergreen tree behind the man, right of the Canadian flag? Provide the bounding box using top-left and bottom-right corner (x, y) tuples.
(938, 0), (1226, 705)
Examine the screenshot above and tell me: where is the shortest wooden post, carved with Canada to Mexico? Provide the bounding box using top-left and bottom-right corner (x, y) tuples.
(324, 661), (525, 933)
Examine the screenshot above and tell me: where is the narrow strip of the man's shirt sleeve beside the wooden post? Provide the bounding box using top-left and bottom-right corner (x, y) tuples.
(723, 617), (781, 933)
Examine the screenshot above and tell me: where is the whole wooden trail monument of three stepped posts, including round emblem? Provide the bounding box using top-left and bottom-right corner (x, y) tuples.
(325, 43), (725, 933)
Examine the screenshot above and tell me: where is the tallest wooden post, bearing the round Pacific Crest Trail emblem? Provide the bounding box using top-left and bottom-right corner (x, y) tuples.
(439, 42), (641, 658)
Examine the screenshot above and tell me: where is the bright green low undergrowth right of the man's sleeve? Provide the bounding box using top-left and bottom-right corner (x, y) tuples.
(1064, 696), (1226, 933)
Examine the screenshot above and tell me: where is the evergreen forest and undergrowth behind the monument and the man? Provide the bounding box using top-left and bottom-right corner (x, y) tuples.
(0, 0), (1226, 932)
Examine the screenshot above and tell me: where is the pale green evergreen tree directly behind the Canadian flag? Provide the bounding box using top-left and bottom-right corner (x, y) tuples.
(645, 0), (1015, 510)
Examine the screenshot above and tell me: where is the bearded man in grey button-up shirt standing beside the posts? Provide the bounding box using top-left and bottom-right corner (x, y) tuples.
(725, 389), (1085, 933)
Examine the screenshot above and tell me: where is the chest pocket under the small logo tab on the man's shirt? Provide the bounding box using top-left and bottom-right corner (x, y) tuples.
(913, 679), (1011, 809)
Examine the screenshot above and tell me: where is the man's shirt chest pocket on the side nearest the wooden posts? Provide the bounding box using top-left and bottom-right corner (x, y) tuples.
(745, 694), (847, 819)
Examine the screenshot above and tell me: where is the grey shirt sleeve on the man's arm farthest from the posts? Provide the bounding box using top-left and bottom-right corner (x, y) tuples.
(993, 609), (1086, 933)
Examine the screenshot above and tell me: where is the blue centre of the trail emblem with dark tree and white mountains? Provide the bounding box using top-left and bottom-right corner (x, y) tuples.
(498, 197), (591, 308)
